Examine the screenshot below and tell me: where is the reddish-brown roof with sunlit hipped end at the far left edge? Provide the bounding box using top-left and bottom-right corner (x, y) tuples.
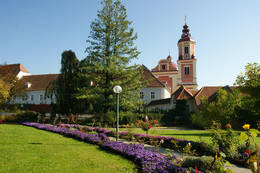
(0, 64), (29, 76)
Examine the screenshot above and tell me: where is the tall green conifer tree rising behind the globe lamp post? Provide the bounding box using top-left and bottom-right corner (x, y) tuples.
(79, 0), (143, 113)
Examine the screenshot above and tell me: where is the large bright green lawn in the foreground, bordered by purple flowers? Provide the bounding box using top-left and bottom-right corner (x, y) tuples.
(0, 124), (137, 173)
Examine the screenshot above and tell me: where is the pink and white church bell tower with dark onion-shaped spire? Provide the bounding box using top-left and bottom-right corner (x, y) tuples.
(177, 17), (198, 89)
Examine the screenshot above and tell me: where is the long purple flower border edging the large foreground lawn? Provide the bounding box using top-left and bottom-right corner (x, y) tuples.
(22, 122), (199, 173)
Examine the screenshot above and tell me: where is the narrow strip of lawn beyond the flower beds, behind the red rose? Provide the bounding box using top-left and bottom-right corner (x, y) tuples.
(120, 128), (260, 147)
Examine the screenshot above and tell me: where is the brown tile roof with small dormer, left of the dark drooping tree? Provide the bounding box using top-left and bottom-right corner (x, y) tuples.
(21, 74), (59, 91)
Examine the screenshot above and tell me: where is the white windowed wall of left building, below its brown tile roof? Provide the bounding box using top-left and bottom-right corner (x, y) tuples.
(11, 90), (55, 105)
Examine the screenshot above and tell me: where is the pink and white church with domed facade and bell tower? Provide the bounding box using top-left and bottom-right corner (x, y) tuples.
(152, 22), (198, 93)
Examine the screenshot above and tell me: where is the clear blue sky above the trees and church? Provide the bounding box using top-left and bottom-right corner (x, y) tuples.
(0, 0), (260, 88)
